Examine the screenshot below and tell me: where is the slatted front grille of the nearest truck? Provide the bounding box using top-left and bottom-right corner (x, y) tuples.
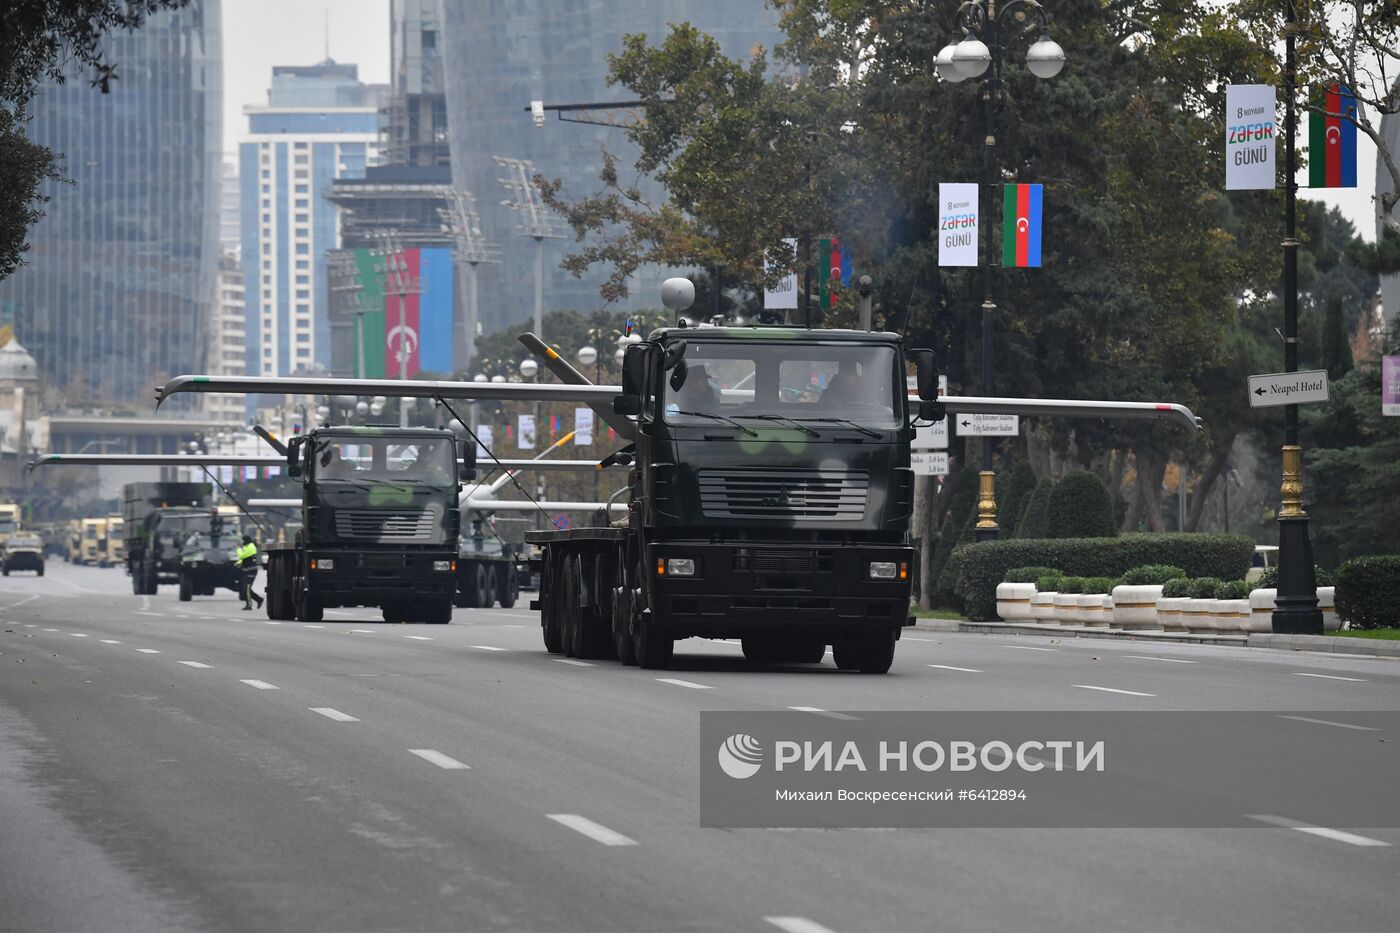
(699, 469), (869, 521)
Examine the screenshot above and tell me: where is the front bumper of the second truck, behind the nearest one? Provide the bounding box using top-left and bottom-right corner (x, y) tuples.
(307, 551), (456, 607)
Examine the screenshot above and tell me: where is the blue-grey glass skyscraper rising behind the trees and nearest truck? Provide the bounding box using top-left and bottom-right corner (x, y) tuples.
(441, 0), (781, 332)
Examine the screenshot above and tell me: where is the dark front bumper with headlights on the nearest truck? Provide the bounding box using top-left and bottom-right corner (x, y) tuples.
(644, 541), (914, 637)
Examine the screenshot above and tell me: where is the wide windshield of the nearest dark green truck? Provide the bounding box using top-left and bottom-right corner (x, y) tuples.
(662, 340), (902, 430)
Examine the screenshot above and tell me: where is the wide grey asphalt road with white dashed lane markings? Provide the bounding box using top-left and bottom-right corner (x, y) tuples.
(0, 562), (1400, 933)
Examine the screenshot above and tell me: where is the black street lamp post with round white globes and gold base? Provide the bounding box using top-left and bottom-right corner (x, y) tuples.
(935, 0), (1064, 541)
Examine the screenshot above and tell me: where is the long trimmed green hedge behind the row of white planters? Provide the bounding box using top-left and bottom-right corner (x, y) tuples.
(956, 534), (1254, 621)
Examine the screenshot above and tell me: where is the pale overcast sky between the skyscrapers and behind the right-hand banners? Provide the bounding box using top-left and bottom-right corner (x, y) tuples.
(223, 0), (1376, 240)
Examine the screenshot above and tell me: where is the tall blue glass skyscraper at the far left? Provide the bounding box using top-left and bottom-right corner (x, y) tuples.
(0, 0), (223, 408)
